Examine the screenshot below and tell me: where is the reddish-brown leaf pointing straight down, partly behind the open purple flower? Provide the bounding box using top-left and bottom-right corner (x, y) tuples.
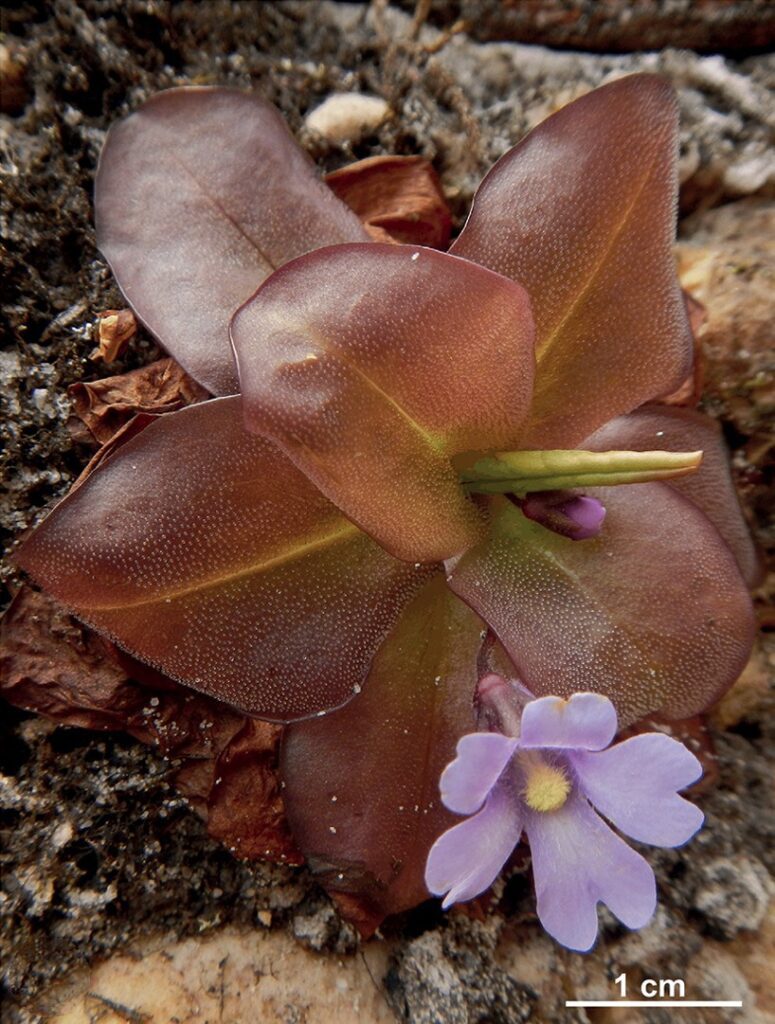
(282, 578), (482, 920)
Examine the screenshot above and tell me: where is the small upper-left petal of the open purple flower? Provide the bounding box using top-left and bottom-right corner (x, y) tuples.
(440, 732), (518, 814)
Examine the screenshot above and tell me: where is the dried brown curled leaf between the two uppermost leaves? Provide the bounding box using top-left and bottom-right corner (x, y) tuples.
(326, 157), (451, 249)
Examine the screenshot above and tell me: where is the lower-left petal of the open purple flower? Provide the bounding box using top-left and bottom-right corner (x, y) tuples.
(425, 785), (522, 909)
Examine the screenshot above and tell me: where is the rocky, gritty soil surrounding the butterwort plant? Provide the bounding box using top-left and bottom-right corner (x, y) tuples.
(0, 0), (775, 1024)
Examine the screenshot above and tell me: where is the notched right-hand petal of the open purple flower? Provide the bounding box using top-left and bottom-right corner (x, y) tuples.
(570, 733), (704, 846)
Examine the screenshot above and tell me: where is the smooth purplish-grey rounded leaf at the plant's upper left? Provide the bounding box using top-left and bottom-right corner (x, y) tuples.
(94, 87), (369, 394)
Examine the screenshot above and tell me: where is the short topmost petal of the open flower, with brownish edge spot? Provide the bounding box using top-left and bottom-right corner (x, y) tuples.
(519, 693), (616, 751)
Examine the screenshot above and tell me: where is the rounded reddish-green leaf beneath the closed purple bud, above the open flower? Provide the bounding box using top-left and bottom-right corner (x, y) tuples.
(448, 483), (754, 727)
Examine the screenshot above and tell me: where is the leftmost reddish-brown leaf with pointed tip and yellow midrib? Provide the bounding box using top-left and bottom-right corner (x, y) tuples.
(17, 397), (434, 720)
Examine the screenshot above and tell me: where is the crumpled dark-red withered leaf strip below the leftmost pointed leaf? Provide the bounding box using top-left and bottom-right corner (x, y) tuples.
(0, 587), (301, 863)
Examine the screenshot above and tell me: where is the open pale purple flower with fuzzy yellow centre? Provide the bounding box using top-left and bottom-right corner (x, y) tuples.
(425, 675), (703, 951)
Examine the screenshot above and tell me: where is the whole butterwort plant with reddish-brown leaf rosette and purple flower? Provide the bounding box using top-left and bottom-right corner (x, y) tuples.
(18, 75), (757, 948)
